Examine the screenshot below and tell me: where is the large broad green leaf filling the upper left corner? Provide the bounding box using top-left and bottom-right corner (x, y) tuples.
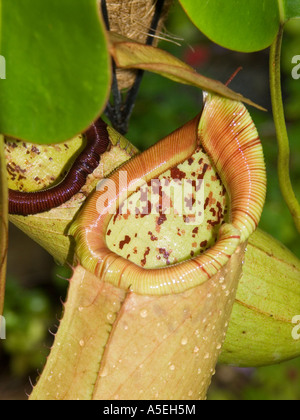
(0, 0), (110, 143)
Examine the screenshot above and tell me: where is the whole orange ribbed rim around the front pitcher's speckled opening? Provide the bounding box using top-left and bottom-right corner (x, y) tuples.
(70, 94), (266, 295)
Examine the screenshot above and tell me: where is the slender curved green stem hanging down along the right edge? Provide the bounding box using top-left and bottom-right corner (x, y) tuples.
(270, 25), (300, 233)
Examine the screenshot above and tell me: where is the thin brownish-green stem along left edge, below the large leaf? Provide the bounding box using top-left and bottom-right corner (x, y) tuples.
(0, 135), (8, 316)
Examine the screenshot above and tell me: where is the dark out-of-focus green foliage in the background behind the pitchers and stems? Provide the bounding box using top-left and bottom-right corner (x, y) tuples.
(0, 0), (300, 400)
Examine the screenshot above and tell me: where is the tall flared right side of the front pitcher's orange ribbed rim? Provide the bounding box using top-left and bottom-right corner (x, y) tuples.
(198, 94), (267, 242)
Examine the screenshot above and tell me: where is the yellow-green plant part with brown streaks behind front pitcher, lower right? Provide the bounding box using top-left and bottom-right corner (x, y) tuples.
(219, 230), (300, 367)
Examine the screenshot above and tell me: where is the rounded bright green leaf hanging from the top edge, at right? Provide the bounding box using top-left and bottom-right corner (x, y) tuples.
(180, 0), (280, 52)
